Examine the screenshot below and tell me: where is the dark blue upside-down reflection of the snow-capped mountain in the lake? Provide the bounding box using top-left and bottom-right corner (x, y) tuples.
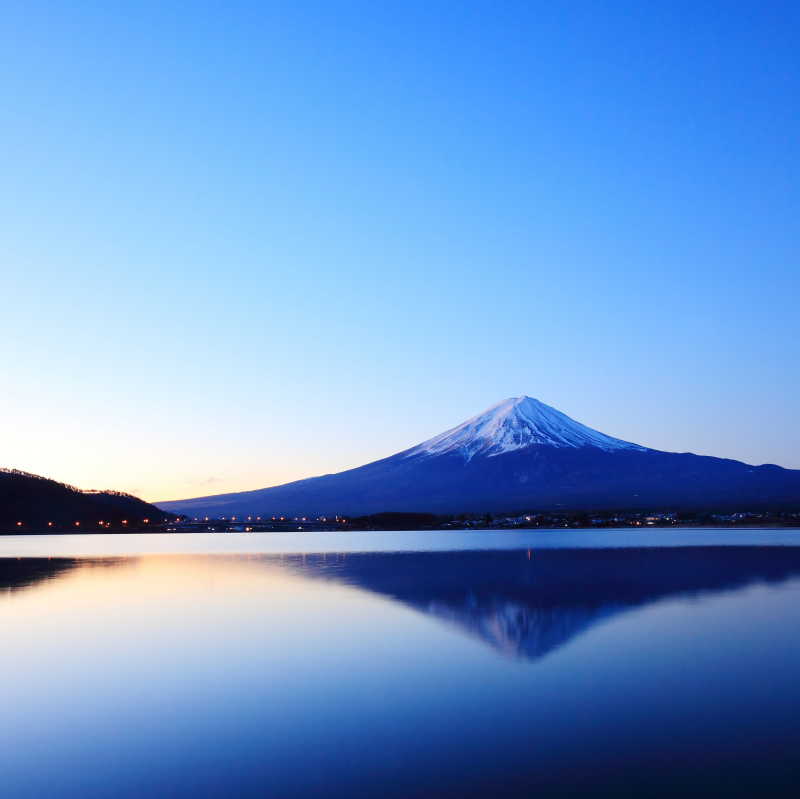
(283, 546), (800, 659)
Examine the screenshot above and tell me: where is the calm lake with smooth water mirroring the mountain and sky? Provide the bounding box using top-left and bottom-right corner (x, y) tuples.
(0, 530), (800, 797)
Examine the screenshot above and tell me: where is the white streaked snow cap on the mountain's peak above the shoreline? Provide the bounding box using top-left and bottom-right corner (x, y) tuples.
(405, 396), (647, 461)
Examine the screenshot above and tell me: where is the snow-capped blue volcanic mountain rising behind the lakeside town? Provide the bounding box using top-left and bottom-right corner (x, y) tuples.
(157, 397), (800, 517)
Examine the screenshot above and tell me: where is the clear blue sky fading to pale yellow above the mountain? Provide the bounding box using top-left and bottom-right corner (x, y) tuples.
(0, 0), (800, 499)
